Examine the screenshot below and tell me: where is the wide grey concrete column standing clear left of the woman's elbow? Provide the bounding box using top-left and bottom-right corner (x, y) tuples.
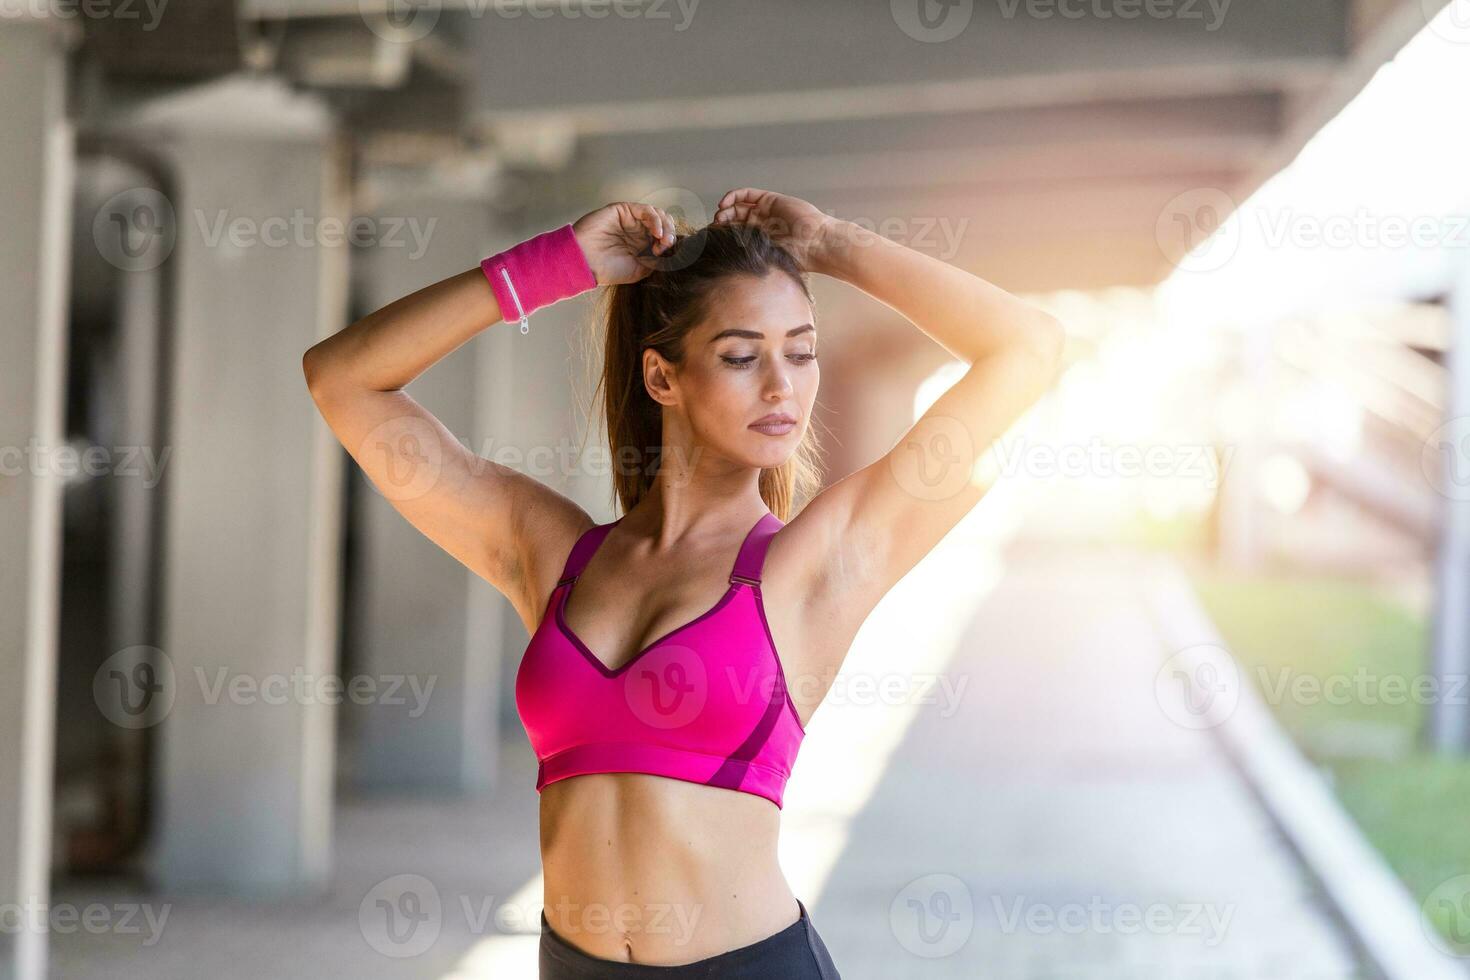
(99, 78), (347, 893)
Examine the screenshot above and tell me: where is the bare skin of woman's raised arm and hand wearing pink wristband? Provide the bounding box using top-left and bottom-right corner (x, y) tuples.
(301, 203), (685, 630)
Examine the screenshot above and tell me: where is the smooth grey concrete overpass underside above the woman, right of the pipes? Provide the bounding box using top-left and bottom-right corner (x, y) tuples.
(463, 0), (1423, 291)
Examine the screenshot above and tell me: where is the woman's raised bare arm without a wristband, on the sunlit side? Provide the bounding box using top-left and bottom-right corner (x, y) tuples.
(716, 188), (1063, 671)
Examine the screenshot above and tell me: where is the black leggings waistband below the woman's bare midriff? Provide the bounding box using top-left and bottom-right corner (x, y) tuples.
(539, 899), (841, 980)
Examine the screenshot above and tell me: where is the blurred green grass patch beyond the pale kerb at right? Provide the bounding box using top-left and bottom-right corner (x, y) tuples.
(1195, 574), (1470, 934)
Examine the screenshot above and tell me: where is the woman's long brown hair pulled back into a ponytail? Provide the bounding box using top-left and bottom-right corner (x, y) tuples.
(592, 222), (820, 520)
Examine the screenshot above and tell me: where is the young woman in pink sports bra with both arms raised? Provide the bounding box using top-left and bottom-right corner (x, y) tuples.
(303, 188), (1061, 980)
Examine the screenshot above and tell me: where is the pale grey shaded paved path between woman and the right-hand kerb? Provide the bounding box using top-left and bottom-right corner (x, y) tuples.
(814, 540), (1370, 980)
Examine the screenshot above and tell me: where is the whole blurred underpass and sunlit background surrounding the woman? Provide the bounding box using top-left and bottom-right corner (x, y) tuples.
(0, 0), (1470, 980)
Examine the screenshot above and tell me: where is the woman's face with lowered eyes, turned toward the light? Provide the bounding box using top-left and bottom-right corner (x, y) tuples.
(657, 272), (820, 469)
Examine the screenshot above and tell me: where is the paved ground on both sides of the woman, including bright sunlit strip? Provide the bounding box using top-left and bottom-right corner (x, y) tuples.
(53, 536), (1369, 980)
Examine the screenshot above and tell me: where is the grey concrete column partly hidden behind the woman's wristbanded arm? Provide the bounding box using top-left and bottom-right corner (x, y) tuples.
(344, 191), (509, 793)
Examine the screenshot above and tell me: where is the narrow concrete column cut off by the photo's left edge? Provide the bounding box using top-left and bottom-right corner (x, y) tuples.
(0, 19), (74, 980)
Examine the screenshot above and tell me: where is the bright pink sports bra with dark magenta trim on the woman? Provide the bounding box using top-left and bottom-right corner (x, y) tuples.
(516, 511), (806, 807)
